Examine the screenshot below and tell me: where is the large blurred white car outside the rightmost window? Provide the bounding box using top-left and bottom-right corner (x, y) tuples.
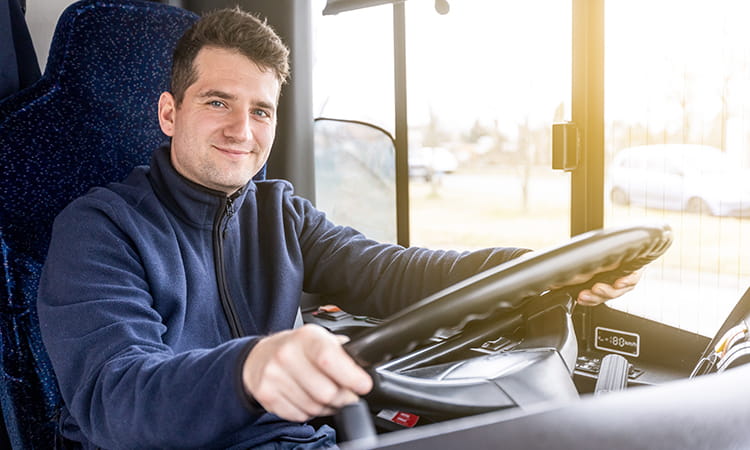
(608, 144), (750, 216)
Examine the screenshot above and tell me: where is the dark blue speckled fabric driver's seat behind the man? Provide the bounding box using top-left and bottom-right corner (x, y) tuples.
(0, 0), (197, 448)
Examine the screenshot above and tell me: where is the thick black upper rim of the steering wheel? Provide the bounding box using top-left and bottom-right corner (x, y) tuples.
(344, 223), (672, 368)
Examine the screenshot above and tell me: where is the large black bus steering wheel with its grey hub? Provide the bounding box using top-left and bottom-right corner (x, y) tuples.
(344, 224), (672, 421)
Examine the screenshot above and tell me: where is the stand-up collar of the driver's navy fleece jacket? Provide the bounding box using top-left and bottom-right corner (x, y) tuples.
(149, 143), (255, 228)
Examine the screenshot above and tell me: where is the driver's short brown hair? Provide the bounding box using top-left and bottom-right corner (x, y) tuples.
(170, 7), (289, 105)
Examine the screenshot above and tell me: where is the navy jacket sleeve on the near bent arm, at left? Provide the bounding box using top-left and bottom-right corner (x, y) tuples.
(38, 203), (262, 448)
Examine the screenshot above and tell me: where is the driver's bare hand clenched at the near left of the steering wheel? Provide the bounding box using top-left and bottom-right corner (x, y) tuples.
(243, 325), (372, 422)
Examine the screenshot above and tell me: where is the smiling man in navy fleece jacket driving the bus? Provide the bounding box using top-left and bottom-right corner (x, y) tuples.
(38, 9), (638, 448)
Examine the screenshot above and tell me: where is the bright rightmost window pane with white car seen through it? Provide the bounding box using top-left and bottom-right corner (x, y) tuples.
(604, 0), (750, 336)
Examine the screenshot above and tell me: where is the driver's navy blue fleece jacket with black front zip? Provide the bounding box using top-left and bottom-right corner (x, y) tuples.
(38, 147), (523, 448)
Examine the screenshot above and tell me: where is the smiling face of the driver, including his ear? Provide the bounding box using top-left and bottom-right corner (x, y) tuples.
(159, 47), (281, 195)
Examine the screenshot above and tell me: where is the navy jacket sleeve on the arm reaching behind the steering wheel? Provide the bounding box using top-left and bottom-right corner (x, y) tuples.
(292, 198), (529, 317)
